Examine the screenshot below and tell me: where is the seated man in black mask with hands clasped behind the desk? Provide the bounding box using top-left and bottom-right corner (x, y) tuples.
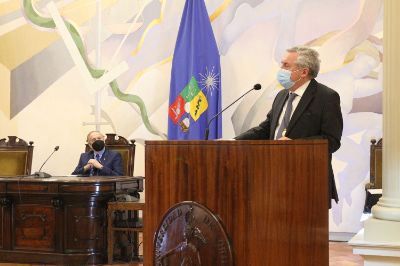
(72, 131), (124, 176)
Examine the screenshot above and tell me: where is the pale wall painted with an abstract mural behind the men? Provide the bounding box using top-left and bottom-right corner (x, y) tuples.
(0, 0), (383, 232)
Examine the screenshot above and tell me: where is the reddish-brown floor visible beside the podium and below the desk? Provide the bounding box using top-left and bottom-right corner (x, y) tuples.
(0, 242), (363, 266)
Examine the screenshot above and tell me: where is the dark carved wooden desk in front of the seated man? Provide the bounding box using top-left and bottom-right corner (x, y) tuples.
(0, 177), (143, 265)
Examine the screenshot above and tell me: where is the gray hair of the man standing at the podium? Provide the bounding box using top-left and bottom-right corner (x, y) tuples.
(286, 46), (321, 78)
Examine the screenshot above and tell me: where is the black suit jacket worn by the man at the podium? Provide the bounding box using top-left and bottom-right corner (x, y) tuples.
(235, 79), (343, 206)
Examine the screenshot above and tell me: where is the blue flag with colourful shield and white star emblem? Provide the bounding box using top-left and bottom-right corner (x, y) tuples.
(168, 0), (222, 140)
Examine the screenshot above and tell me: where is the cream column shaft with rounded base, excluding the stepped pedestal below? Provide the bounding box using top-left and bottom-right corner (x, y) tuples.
(372, 0), (400, 222)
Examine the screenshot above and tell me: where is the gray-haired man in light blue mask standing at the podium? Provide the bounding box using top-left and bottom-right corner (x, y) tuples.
(235, 47), (343, 206)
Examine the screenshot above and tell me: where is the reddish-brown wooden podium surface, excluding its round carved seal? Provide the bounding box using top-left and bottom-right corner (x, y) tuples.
(144, 140), (329, 266)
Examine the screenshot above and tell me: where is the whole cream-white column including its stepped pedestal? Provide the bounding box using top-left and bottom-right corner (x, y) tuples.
(350, 0), (400, 266)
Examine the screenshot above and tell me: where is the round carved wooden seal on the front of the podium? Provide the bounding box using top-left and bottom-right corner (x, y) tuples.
(154, 201), (233, 266)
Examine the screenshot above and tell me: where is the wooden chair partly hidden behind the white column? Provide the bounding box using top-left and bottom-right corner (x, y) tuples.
(364, 139), (382, 213)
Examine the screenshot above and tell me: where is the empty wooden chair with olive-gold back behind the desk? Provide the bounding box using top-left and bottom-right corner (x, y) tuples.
(0, 136), (33, 176)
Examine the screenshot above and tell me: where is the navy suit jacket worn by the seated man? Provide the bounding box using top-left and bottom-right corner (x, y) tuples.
(72, 149), (124, 176)
